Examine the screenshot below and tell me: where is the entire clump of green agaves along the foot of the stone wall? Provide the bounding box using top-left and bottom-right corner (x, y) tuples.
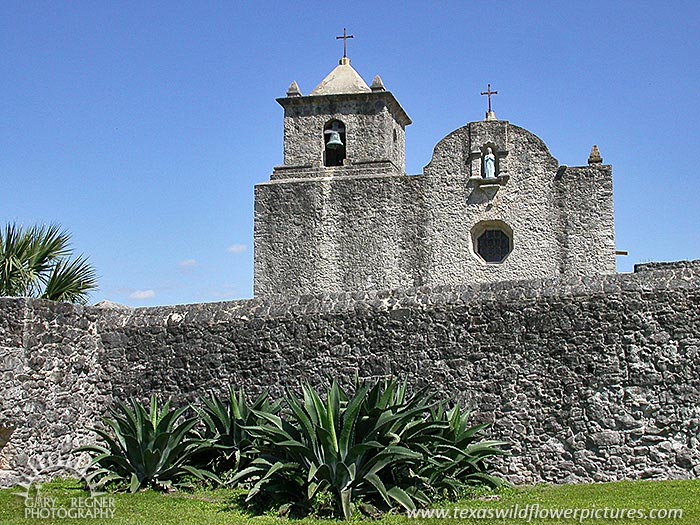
(76, 380), (506, 519)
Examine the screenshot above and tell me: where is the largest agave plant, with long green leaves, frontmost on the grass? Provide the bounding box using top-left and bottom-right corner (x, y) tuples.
(234, 381), (440, 519)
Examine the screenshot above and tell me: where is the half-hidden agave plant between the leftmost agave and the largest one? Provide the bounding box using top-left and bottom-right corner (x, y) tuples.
(195, 387), (280, 474)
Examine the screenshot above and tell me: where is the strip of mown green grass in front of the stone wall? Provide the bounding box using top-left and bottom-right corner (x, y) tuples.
(0, 480), (700, 525)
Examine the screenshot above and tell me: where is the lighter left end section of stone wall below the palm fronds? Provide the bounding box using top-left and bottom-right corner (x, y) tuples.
(0, 298), (112, 485)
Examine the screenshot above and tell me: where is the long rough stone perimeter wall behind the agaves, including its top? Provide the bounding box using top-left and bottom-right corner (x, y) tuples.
(0, 261), (700, 483)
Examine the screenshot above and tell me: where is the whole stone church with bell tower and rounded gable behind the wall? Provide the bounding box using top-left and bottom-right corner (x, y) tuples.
(254, 57), (615, 297)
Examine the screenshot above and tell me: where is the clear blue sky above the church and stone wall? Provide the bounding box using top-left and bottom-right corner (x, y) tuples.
(0, 1), (700, 306)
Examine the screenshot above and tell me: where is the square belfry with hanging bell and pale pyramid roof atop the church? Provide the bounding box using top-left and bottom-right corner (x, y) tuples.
(271, 54), (411, 180)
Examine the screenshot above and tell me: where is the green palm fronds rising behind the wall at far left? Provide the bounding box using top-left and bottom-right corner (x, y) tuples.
(0, 224), (97, 304)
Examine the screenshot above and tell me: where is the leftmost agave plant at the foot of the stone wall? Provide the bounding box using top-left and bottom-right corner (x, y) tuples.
(78, 396), (218, 492)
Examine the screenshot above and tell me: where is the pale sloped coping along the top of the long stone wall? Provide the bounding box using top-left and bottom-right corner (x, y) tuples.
(0, 260), (700, 326)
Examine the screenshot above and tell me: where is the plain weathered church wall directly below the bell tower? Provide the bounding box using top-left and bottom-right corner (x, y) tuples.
(255, 176), (429, 297)
